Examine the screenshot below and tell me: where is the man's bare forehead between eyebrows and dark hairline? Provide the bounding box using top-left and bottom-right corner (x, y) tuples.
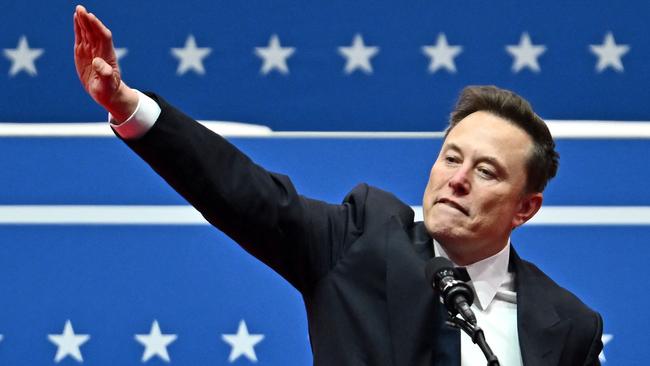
(443, 111), (532, 164)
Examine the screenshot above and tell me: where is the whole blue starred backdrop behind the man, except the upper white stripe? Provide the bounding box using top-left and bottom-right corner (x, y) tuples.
(0, 0), (650, 365)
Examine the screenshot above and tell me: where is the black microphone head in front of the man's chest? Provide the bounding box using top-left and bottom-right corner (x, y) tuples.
(424, 257), (476, 325)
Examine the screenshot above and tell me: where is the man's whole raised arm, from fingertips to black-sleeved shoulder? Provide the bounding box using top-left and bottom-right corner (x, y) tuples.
(74, 6), (382, 291)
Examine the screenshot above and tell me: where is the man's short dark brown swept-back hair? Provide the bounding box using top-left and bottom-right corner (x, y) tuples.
(445, 86), (560, 192)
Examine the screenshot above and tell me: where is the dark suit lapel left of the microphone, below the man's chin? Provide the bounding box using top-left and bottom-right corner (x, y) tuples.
(385, 218), (460, 366)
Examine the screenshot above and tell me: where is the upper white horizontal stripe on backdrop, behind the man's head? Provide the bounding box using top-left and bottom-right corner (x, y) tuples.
(0, 120), (650, 139)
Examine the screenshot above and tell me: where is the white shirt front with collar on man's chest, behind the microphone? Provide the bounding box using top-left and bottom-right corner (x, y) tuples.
(433, 240), (523, 366)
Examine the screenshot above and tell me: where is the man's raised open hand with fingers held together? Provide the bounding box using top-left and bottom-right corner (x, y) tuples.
(74, 5), (138, 121)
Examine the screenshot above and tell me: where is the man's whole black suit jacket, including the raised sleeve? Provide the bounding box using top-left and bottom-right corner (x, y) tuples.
(126, 95), (602, 366)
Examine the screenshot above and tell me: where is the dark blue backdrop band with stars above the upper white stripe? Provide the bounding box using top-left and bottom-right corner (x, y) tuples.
(0, 0), (650, 131)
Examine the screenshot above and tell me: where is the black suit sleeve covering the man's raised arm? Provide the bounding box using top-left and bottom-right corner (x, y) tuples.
(118, 94), (368, 292)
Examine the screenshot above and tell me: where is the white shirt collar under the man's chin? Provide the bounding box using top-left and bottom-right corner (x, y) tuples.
(433, 239), (510, 311)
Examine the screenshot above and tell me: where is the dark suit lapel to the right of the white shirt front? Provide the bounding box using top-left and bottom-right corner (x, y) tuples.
(510, 247), (571, 366)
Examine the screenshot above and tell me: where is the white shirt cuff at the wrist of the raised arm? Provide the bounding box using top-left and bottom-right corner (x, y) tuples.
(108, 90), (161, 140)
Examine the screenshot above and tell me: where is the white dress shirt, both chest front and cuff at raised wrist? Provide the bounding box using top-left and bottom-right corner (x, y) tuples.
(114, 91), (523, 366)
